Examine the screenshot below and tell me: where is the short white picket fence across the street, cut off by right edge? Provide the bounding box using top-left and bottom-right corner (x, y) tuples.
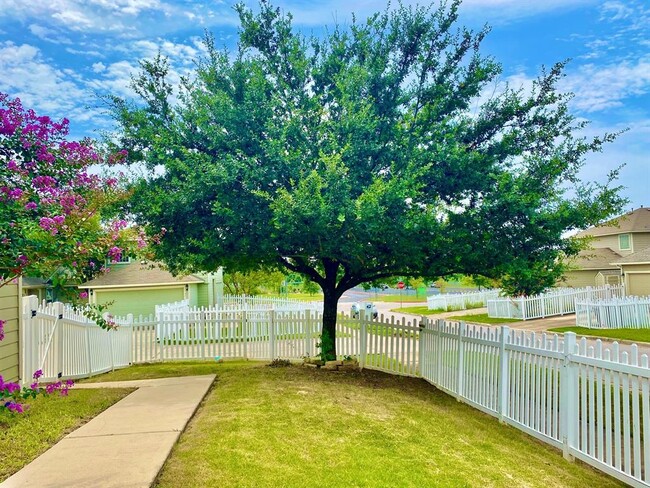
(576, 297), (650, 329)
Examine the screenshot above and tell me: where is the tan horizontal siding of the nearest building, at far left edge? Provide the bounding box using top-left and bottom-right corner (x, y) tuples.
(0, 284), (20, 381)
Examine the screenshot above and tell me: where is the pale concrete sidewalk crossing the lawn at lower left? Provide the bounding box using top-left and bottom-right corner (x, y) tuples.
(0, 375), (215, 488)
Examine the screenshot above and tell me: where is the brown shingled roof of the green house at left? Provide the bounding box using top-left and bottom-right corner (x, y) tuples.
(79, 263), (204, 288)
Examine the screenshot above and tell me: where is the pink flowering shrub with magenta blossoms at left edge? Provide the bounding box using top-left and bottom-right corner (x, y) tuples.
(0, 93), (135, 286)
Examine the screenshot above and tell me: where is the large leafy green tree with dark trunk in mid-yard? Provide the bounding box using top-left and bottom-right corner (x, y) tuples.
(111, 1), (621, 357)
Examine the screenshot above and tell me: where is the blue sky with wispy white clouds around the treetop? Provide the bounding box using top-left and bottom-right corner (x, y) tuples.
(0, 0), (650, 208)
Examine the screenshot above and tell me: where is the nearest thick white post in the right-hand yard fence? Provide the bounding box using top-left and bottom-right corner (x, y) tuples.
(559, 332), (579, 461)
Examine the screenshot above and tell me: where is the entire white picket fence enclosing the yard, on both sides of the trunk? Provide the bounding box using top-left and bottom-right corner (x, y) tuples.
(23, 296), (650, 487)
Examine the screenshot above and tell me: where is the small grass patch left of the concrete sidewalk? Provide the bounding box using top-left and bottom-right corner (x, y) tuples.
(0, 388), (133, 482)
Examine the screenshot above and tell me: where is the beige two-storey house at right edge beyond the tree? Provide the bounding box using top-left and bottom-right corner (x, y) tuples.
(562, 207), (650, 295)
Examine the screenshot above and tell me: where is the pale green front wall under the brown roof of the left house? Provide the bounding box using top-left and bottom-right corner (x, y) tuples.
(94, 284), (185, 317)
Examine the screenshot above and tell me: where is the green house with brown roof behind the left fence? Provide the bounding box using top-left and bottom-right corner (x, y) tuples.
(79, 260), (223, 317)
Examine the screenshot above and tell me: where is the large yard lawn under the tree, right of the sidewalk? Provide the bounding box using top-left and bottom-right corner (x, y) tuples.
(103, 362), (623, 488)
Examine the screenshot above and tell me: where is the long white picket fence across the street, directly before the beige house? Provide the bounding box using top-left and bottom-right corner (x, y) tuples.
(487, 285), (625, 320)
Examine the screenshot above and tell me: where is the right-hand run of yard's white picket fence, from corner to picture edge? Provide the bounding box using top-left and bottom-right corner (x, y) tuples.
(420, 321), (650, 487)
